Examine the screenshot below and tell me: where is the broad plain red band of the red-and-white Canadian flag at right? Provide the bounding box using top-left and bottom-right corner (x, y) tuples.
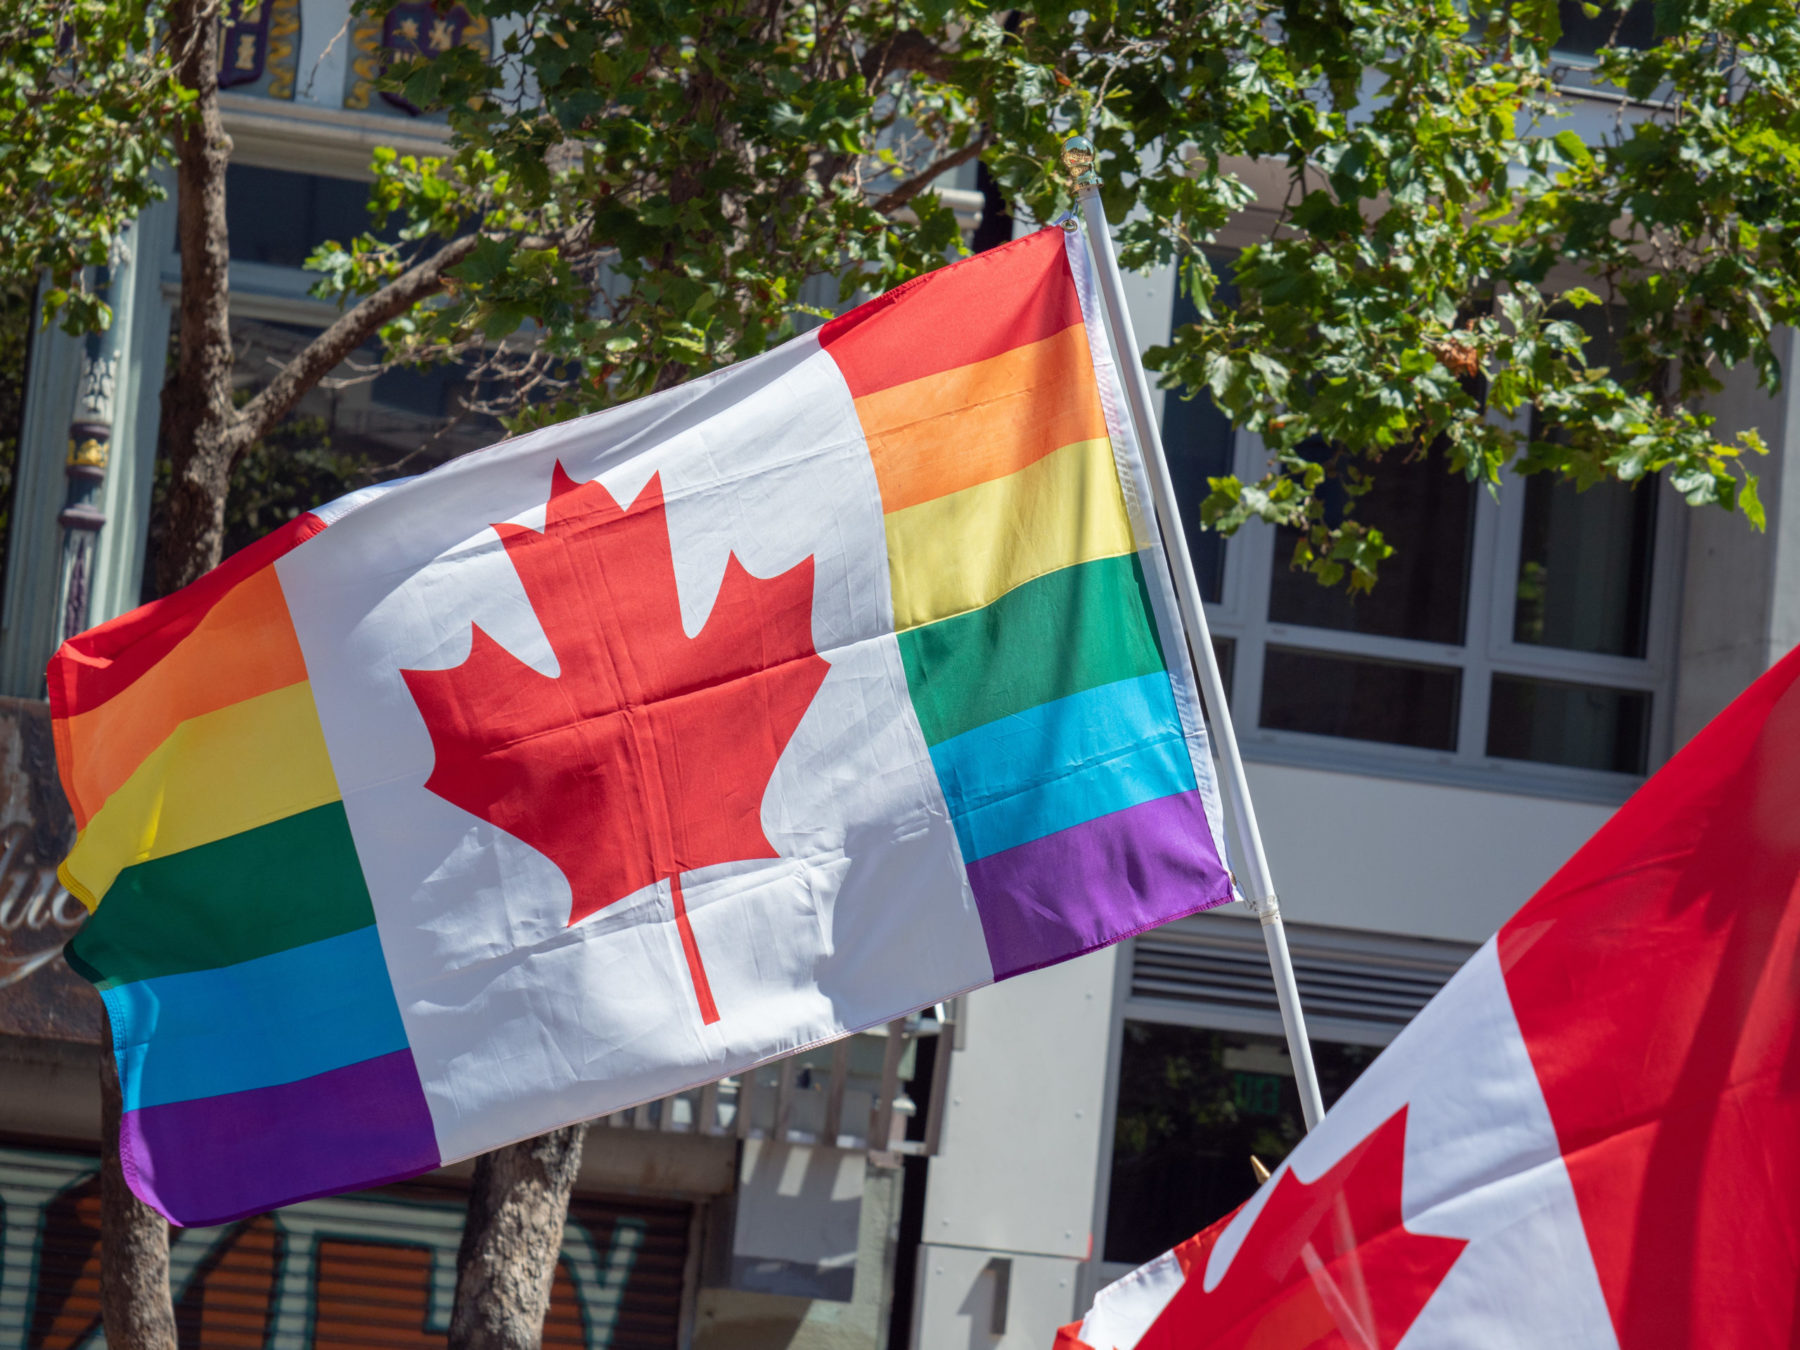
(1499, 653), (1800, 1348)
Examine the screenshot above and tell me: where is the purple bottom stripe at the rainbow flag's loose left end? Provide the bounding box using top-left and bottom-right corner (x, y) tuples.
(119, 1049), (437, 1228)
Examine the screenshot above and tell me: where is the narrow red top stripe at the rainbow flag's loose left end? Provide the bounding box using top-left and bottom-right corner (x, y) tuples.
(45, 513), (326, 720)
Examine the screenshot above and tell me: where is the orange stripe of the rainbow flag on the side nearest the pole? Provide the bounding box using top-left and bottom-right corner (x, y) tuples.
(857, 324), (1107, 511)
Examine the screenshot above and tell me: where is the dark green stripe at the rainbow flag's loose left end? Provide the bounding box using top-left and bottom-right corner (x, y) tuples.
(65, 801), (374, 990)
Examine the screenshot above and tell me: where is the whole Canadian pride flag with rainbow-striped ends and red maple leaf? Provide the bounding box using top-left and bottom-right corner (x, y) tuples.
(49, 230), (1231, 1224)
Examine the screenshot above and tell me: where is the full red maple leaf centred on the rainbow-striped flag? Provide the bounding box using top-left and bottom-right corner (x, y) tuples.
(401, 464), (828, 1022)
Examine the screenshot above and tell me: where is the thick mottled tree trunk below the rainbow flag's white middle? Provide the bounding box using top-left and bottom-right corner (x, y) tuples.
(450, 1125), (587, 1350)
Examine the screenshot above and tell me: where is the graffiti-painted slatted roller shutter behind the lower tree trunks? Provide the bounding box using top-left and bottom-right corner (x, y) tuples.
(0, 1148), (691, 1350)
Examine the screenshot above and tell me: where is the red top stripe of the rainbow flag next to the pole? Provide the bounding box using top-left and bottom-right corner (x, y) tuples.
(819, 229), (1082, 398)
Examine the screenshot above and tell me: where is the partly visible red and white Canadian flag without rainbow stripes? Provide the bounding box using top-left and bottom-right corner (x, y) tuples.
(1057, 652), (1800, 1350)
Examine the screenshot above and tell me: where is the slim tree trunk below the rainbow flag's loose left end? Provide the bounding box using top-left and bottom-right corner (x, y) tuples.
(101, 1019), (175, 1350)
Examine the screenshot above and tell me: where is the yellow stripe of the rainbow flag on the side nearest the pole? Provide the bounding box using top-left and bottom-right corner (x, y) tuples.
(887, 439), (1136, 632)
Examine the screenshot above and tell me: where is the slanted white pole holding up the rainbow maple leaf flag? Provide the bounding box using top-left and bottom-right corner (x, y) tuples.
(1062, 137), (1325, 1130)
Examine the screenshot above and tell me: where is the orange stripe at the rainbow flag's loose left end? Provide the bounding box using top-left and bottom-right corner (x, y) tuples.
(56, 567), (306, 828)
